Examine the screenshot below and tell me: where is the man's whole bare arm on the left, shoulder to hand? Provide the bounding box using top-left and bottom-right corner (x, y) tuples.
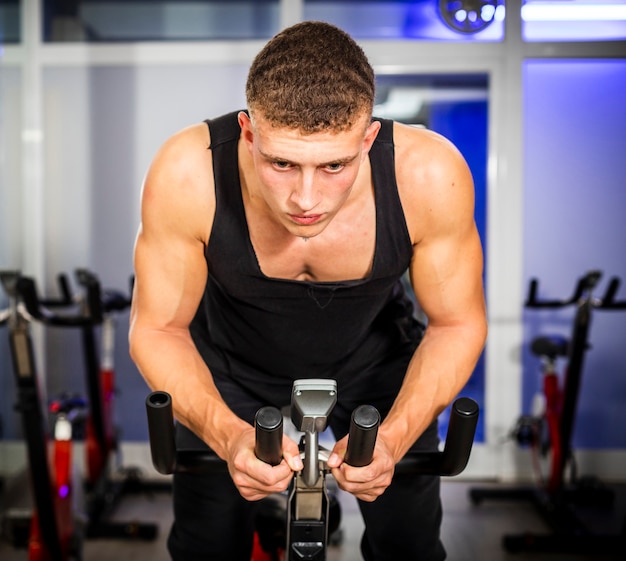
(130, 125), (299, 499)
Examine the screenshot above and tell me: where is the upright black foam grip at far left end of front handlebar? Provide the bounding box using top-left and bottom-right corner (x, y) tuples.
(146, 391), (176, 475)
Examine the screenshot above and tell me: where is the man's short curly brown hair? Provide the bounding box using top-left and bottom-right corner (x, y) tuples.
(246, 21), (375, 133)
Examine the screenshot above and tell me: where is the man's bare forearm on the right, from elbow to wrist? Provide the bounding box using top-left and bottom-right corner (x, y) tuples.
(379, 320), (486, 462)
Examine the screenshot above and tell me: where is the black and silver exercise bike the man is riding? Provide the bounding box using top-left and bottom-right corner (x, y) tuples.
(146, 379), (478, 561)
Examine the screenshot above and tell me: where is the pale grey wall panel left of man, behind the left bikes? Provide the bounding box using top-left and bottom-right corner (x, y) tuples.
(38, 65), (246, 440)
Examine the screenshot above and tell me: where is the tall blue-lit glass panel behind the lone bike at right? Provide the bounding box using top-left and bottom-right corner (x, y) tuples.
(522, 60), (626, 449)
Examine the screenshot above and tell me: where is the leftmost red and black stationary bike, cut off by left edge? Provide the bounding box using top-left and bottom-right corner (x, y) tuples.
(0, 271), (86, 561)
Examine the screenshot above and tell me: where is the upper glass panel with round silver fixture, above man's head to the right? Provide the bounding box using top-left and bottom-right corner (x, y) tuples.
(304, 0), (504, 41)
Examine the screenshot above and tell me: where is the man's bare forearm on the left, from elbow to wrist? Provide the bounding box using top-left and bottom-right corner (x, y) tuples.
(130, 326), (250, 459)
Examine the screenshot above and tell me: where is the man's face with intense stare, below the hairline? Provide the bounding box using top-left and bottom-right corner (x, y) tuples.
(239, 112), (380, 238)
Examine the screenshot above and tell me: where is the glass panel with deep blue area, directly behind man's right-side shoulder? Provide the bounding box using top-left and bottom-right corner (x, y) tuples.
(374, 74), (488, 442)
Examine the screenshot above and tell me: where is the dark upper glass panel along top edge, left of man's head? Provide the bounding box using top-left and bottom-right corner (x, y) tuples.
(44, 0), (279, 42)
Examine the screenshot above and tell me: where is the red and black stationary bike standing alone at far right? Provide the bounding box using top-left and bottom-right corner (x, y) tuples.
(470, 271), (626, 555)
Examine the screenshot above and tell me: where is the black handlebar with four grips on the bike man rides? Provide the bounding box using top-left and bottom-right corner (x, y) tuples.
(146, 391), (479, 476)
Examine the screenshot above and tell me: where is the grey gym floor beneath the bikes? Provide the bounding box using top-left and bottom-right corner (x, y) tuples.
(0, 479), (626, 561)
